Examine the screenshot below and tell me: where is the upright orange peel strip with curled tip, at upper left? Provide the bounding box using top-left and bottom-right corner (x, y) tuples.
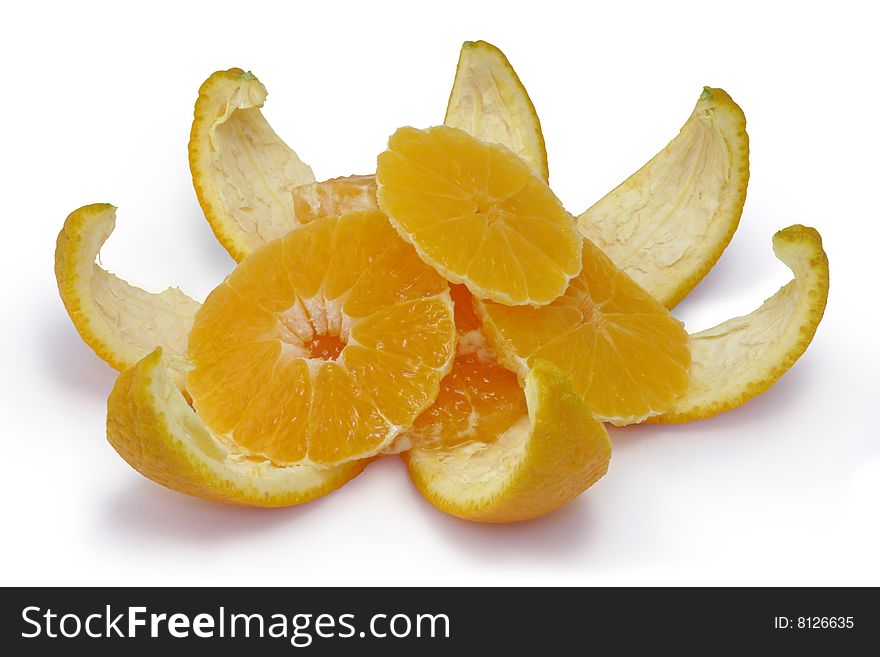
(189, 68), (315, 260)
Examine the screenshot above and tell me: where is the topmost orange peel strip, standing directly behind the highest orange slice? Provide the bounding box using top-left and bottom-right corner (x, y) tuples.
(443, 41), (549, 181)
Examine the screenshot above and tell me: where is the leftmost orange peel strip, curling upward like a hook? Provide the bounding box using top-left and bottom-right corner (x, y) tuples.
(55, 203), (199, 370)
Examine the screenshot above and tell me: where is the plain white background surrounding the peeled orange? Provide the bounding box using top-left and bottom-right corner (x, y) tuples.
(0, 0), (880, 585)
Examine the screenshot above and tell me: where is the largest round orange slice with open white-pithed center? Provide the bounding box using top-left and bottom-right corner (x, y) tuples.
(187, 210), (455, 467)
